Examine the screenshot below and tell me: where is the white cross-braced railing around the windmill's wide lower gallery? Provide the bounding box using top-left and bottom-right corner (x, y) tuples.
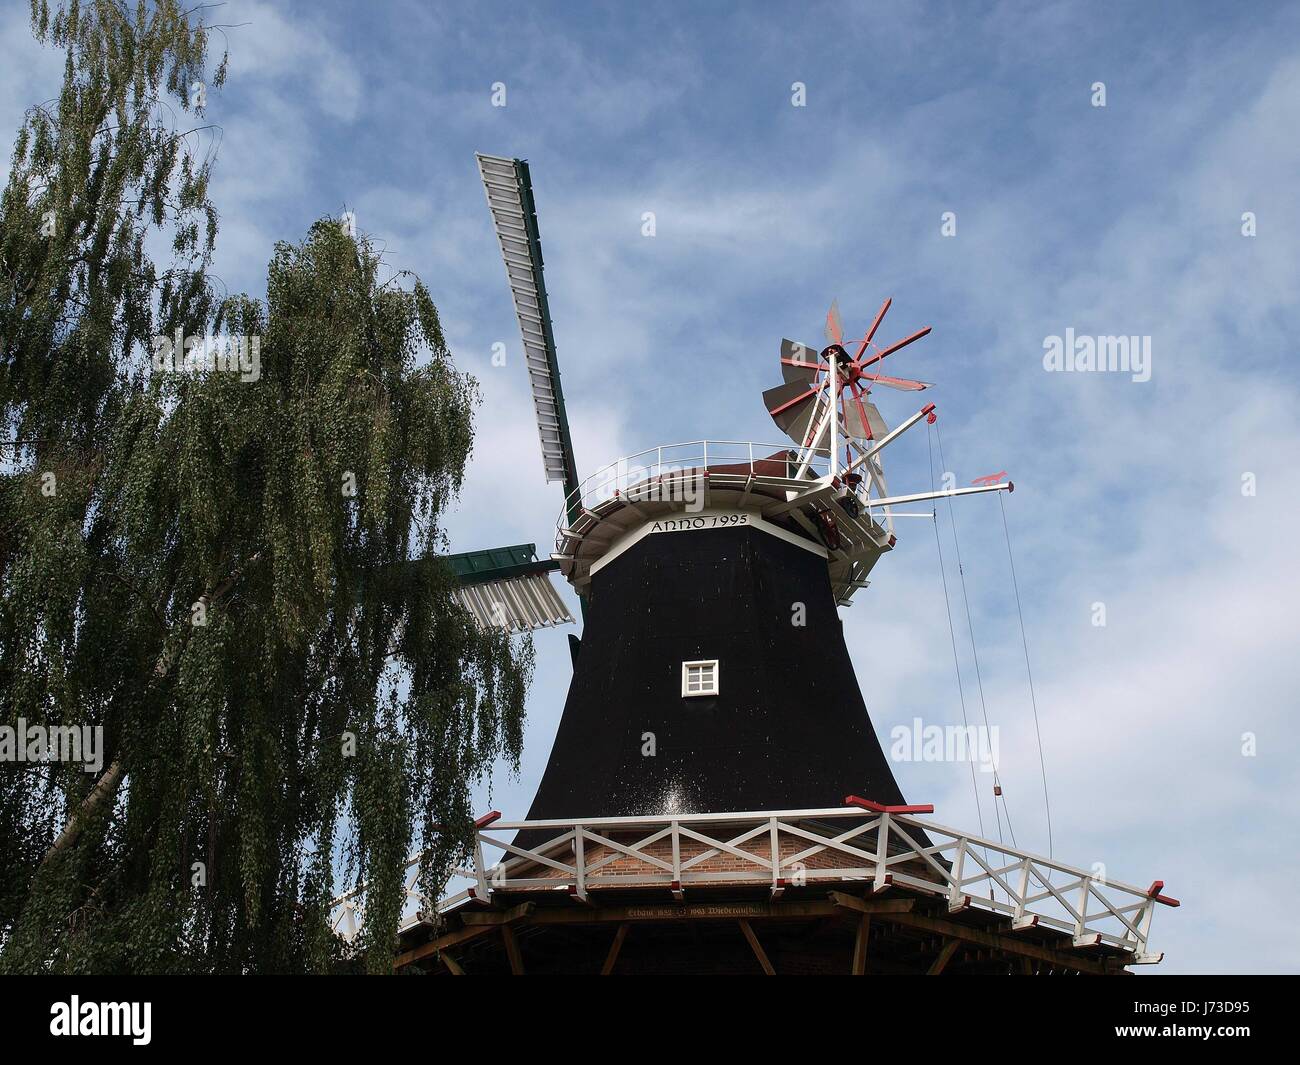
(332, 798), (1178, 965)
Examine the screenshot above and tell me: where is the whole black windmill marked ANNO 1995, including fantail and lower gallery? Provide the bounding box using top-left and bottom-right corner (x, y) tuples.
(335, 155), (1178, 974)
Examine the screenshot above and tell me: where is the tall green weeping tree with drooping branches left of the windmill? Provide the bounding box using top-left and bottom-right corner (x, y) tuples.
(0, 0), (532, 971)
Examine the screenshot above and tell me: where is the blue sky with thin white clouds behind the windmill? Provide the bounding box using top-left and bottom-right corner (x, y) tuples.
(0, 0), (1300, 974)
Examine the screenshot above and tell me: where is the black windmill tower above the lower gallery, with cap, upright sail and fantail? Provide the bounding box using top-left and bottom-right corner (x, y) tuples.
(478, 155), (982, 840)
